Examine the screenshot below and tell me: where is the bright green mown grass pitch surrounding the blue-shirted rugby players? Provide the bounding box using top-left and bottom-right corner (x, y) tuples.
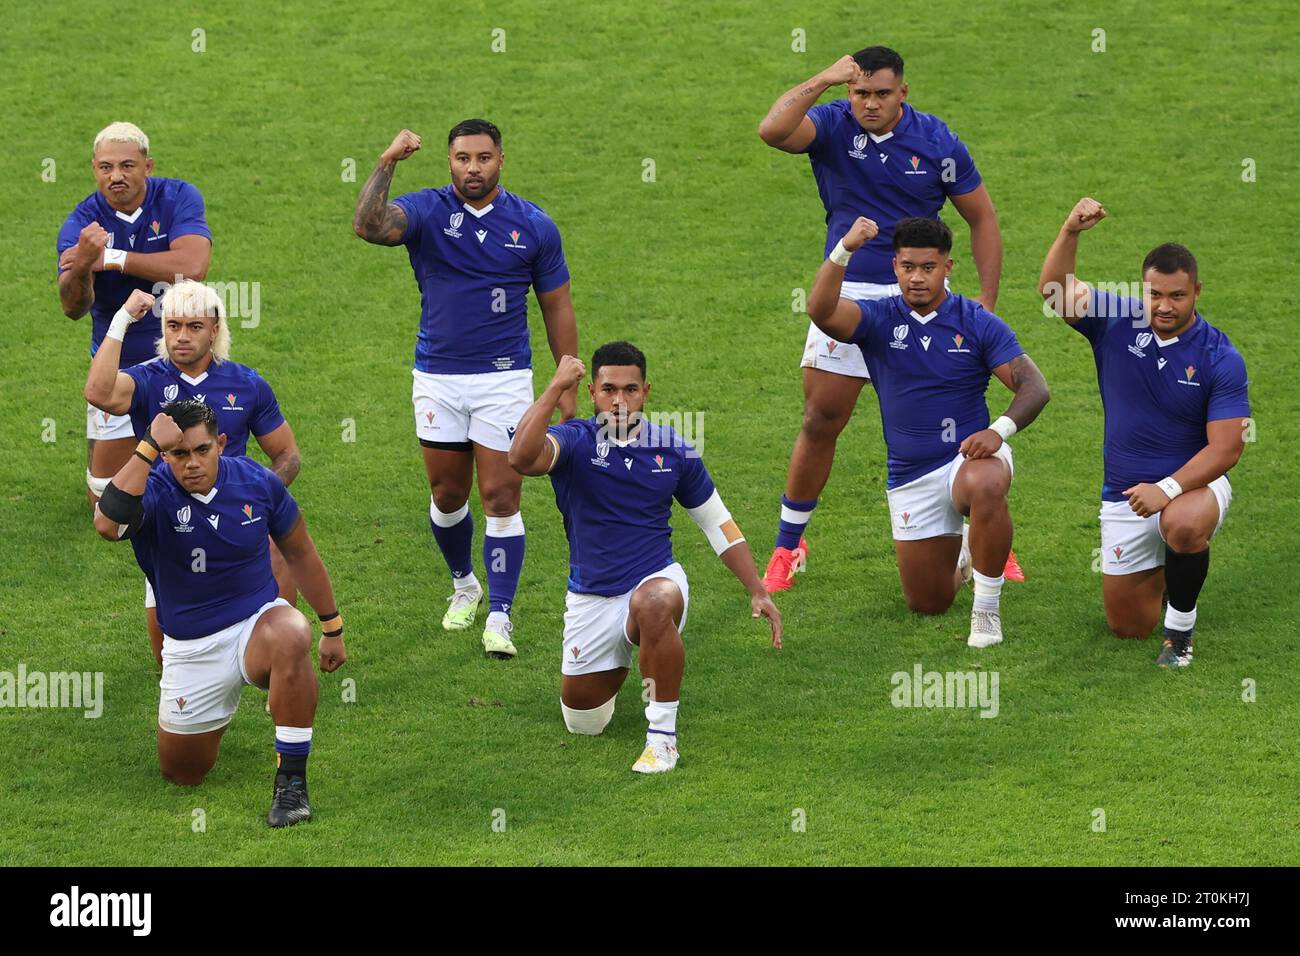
(0, 0), (1300, 865)
